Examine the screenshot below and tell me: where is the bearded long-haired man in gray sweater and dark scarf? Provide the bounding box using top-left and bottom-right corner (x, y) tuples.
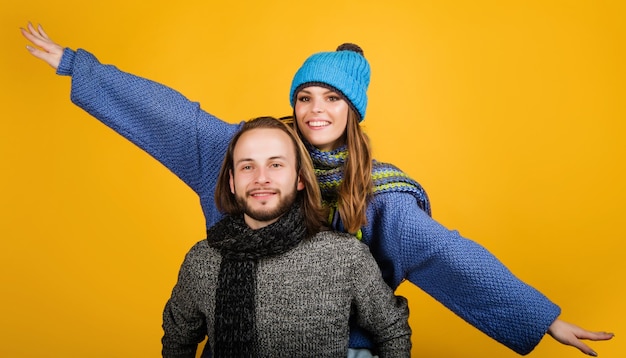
(162, 117), (411, 357)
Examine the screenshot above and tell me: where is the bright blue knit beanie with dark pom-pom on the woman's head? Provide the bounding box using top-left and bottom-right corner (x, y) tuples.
(289, 43), (370, 122)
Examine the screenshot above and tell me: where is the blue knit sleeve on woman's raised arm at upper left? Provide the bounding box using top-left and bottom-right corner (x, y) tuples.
(57, 48), (239, 193)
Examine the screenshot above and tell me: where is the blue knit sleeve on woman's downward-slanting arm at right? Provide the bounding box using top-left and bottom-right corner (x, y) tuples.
(370, 193), (560, 355)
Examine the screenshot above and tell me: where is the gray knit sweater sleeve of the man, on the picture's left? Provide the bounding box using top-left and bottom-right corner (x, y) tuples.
(161, 245), (207, 358)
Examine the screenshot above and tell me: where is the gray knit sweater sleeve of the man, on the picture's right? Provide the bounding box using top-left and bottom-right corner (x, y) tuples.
(351, 240), (411, 358)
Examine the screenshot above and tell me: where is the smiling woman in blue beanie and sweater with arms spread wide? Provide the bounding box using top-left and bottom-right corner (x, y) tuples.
(21, 24), (612, 355)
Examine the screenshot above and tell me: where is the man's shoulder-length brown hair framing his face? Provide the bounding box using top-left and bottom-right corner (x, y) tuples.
(215, 117), (327, 235)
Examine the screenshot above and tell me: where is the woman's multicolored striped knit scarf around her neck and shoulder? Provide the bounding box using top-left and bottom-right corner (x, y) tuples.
(305, 143), (431, 238)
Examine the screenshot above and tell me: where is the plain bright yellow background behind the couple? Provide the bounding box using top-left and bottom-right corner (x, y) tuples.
(0, 0), (626, 358)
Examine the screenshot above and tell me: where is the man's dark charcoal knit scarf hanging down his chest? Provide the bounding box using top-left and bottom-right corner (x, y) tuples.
(207, 200), (307, 358)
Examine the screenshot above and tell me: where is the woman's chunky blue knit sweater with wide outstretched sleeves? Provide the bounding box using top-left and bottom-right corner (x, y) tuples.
(57, 49), (560, 354)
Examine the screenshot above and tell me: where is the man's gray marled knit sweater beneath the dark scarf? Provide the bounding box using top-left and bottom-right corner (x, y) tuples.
(162, 231), (411, 358)
